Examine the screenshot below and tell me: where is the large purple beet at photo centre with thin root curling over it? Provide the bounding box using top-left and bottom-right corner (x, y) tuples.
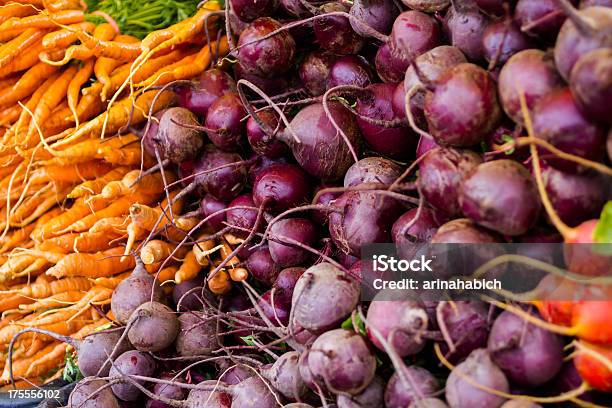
(283, 101), (361, 181)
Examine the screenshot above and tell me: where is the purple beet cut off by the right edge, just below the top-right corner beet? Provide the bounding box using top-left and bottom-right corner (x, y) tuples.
(570, 48), (612, 125)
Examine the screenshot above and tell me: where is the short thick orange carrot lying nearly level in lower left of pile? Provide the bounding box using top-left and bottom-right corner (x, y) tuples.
(46, 247), (136, 278)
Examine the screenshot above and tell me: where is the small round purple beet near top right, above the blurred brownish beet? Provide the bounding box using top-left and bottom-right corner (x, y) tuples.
(482, 20), (531, 65)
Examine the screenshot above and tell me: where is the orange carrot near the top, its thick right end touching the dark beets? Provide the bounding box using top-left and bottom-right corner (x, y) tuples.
(137, 37), (229, 87)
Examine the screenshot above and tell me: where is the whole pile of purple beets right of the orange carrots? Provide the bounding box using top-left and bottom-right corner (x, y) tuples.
(51, 0), (612, 408)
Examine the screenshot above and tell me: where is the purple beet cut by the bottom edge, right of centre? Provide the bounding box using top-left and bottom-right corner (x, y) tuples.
(385, 366), (440, 408)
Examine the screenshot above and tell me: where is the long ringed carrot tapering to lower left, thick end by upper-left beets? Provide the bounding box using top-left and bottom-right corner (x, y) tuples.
(51, 91), (175, 146)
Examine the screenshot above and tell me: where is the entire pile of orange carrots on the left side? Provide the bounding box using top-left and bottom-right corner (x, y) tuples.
(0, 0), (230, 387)
